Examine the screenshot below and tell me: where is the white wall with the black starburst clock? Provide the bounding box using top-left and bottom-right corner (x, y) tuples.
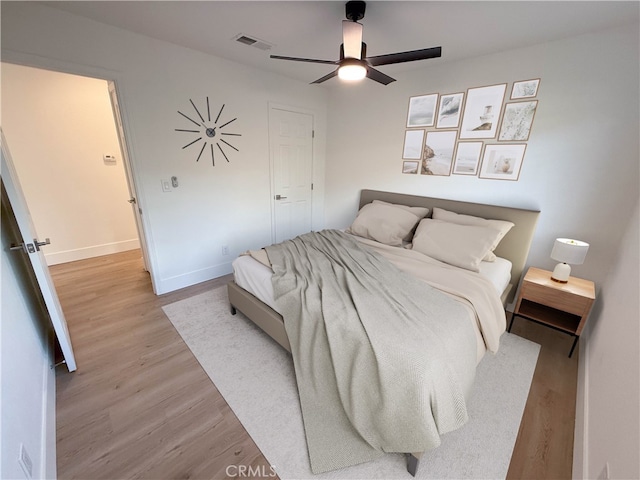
(2, 2), (327, 293)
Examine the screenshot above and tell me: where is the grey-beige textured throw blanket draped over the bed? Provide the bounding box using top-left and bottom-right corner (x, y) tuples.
(266, 230), (490, 473)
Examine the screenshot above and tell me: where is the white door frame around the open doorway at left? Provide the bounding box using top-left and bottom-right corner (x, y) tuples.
(0, 49), (160, 295)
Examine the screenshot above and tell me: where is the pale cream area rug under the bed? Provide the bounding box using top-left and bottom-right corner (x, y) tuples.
(163, 286), (540, 480)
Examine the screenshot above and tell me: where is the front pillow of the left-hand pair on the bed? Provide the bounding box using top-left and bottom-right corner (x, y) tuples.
(347, 203), (420, 246)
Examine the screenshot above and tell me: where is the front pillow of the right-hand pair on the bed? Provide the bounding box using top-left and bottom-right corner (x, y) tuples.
(412, 218), (500, 272)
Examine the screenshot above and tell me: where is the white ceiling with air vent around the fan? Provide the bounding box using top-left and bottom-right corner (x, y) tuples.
(44, 1), (640, 86)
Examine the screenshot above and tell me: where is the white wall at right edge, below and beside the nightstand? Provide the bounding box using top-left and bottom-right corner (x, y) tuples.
(579, 204), (640, 478)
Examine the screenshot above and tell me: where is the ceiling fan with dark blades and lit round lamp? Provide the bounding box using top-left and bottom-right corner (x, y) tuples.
(271, 0), (442, 85)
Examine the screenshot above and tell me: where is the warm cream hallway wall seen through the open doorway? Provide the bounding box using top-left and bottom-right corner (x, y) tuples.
(1, 63), (140, 265)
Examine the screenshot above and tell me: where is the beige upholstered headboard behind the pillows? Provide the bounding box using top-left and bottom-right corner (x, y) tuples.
(359, 190), (540, 303)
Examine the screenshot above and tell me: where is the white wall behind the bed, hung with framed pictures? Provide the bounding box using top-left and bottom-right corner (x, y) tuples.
(326, 24), (640, 285)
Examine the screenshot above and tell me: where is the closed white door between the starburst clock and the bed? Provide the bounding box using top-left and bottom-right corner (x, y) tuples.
(269, 107), (313, 243)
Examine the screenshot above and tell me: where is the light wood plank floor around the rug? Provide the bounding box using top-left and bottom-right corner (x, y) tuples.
(51, 250), (577, 479)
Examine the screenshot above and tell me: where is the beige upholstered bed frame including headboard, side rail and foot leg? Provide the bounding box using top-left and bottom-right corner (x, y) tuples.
(227, 190), (540, 475)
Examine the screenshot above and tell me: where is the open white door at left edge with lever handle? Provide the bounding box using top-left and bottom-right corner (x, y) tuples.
(0, 129), (76, 372)
